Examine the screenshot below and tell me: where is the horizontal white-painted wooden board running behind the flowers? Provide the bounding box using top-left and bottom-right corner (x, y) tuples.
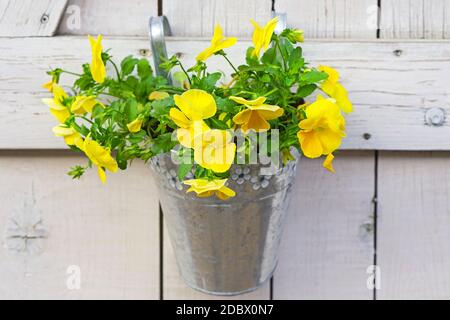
(0, 36), (450, 150)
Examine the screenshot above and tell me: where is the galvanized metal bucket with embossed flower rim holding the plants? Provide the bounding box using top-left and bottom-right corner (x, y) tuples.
(150, 154), (297, 295)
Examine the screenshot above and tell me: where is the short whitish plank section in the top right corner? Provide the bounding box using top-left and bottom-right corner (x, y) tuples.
(380, 0), (450, 39)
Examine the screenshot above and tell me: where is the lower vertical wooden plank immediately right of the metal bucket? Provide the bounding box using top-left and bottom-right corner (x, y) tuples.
(273, 152), (375, 299)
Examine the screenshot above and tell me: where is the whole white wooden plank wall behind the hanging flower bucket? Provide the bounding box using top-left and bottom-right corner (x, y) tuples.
(0, 0), (450, 299)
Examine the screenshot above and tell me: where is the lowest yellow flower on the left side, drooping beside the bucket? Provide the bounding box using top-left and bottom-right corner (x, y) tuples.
(75, 136), (119, 183)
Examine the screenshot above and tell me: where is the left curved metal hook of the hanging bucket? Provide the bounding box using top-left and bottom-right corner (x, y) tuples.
(149, 16), (172, 84)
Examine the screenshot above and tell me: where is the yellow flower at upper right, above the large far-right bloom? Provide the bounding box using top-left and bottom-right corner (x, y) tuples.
(318, 66), (353, 113)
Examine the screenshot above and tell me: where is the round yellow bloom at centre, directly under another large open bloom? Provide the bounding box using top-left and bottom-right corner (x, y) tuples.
(194, 129), (236, 173)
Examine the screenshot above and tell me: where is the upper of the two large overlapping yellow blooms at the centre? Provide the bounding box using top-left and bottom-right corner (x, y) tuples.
(169, 89), (217, 148)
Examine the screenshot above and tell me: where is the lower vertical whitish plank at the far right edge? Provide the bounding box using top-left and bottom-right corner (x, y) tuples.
(377, 152), (450, 299)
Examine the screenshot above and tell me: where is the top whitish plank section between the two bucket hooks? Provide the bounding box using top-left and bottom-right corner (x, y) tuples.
(162, 0), (272, 37)
